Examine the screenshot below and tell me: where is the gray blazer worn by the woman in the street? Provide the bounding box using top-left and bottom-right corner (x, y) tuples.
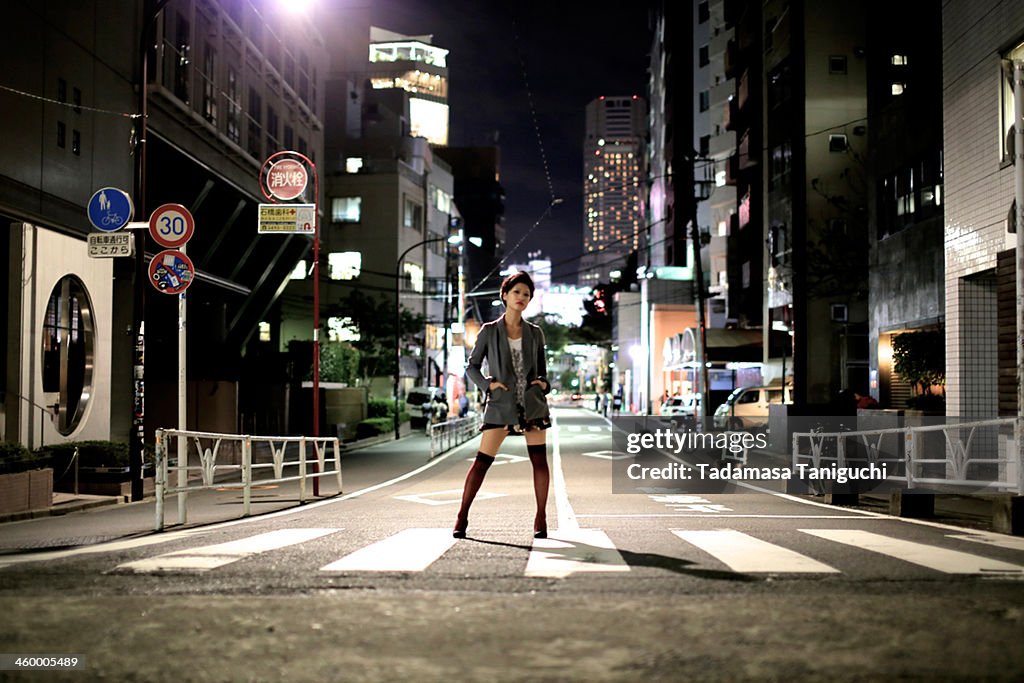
(466, 315), (551, 425)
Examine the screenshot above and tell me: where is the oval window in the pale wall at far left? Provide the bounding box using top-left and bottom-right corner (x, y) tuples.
(41, 275), (94, 435)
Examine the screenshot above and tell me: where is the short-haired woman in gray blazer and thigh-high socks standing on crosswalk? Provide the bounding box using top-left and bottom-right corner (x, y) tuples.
(452, 272), (551, 539)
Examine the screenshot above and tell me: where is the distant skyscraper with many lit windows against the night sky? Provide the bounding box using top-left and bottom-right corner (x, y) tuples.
(580, 95), (646, 285)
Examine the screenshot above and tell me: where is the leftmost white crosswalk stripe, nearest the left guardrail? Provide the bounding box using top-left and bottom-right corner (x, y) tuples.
(117, 528), (341, 572)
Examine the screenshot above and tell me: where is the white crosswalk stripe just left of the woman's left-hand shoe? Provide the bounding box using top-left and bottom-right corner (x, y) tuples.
(321, 528), (456, 571)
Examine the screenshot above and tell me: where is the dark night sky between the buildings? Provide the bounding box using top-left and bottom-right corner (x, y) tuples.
(372, 0), (651, 282)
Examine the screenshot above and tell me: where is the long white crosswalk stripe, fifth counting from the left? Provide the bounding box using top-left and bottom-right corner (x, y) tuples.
(800, 528), (1024, 574)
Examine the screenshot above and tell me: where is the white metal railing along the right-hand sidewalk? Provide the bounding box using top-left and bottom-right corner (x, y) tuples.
(793, 418), (1024, 494)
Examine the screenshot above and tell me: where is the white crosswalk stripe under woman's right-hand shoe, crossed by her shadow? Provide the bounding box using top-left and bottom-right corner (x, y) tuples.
(525, 528), (630, 579)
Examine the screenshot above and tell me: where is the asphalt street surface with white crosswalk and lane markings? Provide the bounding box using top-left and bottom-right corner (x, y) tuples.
(0, 409), (1024, 681)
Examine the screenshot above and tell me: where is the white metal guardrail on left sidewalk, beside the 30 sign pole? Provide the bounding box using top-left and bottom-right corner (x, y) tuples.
(156, 429), (342, 531)
